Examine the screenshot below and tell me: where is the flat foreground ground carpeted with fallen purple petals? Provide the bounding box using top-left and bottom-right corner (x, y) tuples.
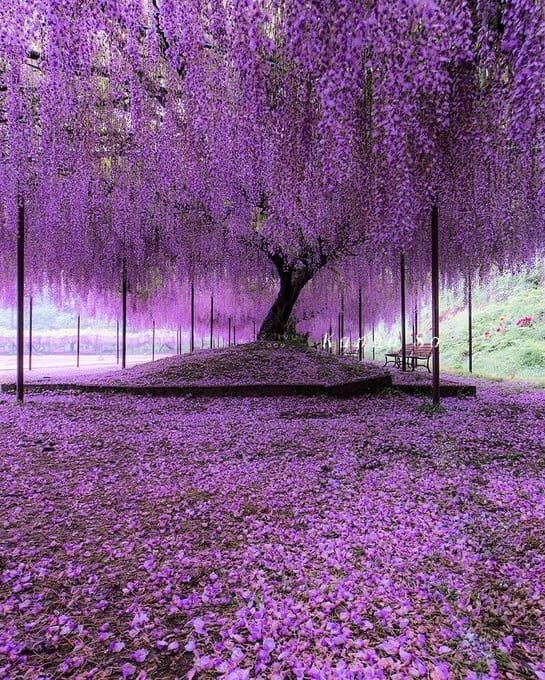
(0, 384), (545, 680)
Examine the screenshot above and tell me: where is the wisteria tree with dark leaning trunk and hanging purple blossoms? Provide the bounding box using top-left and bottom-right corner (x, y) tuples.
(0, 0), (545, 337)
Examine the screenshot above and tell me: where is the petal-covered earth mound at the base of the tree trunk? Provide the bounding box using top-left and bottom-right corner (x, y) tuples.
(83, 343), (384, 386)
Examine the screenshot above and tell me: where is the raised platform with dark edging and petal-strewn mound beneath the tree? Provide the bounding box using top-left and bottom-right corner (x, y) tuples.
(1, 343), (476, 398)
